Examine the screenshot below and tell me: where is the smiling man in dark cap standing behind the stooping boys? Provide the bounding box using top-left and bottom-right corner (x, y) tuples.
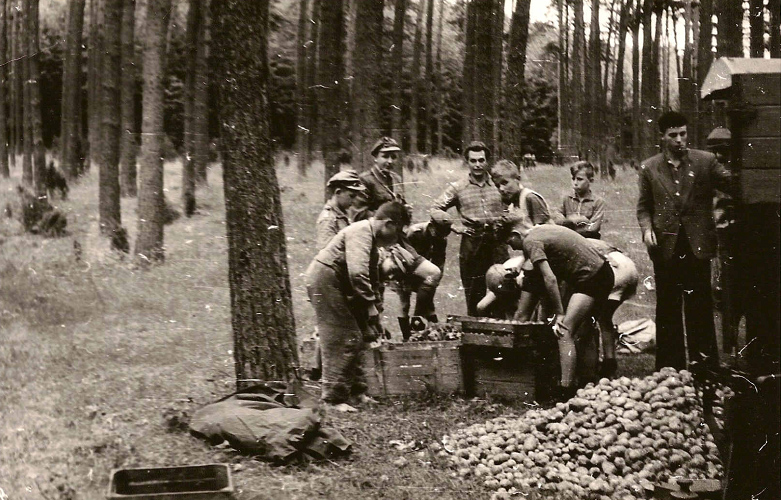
(353, 136), (406, 221)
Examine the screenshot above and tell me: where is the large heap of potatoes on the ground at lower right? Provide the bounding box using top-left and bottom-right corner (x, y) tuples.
(442, 368), (722, 500)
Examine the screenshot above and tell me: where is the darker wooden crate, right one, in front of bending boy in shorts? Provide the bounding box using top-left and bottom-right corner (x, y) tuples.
(461, 323), (559, 401)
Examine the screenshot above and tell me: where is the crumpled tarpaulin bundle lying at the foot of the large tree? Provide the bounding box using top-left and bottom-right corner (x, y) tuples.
(190, 382), (352, 463)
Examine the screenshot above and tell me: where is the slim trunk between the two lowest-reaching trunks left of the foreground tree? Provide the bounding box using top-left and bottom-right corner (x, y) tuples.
(119, 0), (138, 197)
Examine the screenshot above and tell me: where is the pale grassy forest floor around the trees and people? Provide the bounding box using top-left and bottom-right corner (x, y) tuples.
(0, 154), (654, 500)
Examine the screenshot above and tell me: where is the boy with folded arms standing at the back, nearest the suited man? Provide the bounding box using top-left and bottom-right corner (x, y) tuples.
(561, 161), (605, 239)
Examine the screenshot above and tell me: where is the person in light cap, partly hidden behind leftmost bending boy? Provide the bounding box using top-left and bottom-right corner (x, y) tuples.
(317, 170), (366, 249)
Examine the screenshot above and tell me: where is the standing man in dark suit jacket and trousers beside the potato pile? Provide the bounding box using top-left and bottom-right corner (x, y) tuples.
(637, 111), (730, 369)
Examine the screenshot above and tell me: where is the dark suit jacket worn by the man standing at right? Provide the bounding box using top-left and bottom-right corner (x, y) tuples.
(637, 149), (730, 260)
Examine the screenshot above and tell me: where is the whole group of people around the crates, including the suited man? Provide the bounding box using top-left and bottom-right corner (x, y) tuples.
(307, 113), (726, 411)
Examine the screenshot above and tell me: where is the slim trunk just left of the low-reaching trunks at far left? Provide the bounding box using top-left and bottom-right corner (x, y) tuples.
(87, 0), (104, 167)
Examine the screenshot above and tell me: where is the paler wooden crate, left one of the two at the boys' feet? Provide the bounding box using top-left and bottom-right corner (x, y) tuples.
(300, 340), (463, 396)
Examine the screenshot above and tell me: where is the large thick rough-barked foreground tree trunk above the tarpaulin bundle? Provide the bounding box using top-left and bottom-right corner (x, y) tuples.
(214, 0), (298, 387)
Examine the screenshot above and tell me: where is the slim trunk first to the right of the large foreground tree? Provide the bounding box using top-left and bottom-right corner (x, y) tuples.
(296, 0), (308, 177)
